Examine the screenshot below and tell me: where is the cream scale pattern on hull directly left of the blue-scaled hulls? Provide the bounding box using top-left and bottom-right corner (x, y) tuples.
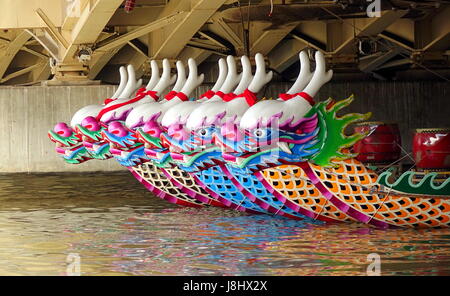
(161, 166), (227, 208)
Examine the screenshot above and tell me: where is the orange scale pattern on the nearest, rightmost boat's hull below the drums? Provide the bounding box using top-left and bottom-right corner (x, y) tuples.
(309, 159), (450, 227)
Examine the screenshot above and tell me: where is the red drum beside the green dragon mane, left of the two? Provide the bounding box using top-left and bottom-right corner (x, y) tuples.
(353, 121), (402, 163)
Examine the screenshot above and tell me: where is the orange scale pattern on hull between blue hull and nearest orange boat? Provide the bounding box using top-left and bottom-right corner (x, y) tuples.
(260, 165), (356, 222)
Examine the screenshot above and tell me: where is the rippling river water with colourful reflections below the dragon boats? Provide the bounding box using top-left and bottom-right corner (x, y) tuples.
(0, 172), (450, 275)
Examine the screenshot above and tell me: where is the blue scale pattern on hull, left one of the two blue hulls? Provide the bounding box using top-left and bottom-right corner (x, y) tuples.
(191, 166), (268, 214)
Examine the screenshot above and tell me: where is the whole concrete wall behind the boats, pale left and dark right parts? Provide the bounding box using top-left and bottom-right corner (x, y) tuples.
(0, 81), (450, 172)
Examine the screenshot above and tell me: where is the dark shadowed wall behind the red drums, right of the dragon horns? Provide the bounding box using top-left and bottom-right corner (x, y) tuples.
(267, 81), (450, 151)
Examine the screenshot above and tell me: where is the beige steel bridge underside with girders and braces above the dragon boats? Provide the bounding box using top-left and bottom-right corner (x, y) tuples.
(0, 0), (450, 85)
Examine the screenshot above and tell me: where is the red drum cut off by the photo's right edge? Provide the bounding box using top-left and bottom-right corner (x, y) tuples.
(413, 128), (450, 169)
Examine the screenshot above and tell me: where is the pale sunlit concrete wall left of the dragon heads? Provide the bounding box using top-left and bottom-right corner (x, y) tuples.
(0, 86), (124, 172)
